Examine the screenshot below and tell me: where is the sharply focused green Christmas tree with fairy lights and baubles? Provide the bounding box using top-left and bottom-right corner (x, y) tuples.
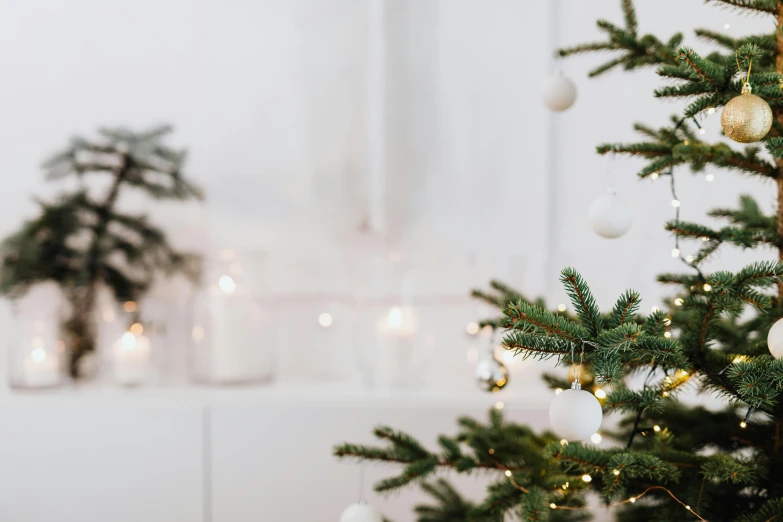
(335, 0), (783, 522)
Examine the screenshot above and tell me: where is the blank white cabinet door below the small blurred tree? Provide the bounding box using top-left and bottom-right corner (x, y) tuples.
(0, 397), (203, 522)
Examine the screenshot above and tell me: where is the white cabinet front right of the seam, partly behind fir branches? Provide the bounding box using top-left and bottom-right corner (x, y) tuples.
(212, 395), (547, 522)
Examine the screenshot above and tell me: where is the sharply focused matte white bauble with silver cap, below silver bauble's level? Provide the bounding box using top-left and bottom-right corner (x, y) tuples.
(549, 382), (603, 441)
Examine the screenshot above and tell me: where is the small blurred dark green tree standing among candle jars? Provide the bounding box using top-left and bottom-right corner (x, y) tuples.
(0, 126), (202, 377)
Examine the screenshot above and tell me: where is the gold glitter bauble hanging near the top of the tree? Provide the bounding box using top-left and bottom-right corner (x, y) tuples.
(720, 83), (772, 143)
